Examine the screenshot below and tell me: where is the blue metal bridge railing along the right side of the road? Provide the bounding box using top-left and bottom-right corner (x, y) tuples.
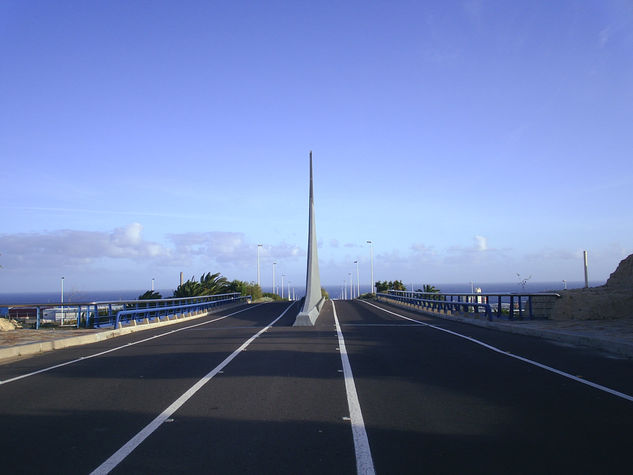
(377, 290), (560, 320)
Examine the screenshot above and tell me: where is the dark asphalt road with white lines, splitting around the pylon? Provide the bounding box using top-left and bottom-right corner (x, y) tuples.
(0, 301), (633, 474)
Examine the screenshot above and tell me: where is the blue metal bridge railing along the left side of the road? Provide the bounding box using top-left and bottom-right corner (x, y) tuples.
(0, 292), (251, 329)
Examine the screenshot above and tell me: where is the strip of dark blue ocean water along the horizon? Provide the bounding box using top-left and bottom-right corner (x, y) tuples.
(0, 281), (604, 305)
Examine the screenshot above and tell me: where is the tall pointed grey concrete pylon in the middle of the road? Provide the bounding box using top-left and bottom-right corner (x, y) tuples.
(294, 151), (325, 327)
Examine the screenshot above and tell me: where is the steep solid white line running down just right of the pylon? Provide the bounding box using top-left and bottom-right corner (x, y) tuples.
(332, 302), (376, 475)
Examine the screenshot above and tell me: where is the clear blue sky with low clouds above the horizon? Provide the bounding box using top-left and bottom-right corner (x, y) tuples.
(0, 0), (633, 292)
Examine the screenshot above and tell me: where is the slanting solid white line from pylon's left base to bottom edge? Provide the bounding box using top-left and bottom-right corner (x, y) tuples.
(90, 302), (294, 475)
